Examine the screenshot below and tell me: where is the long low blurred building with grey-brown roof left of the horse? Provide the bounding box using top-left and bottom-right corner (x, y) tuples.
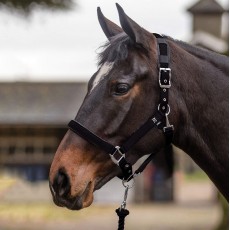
(0, 82), (86, 181)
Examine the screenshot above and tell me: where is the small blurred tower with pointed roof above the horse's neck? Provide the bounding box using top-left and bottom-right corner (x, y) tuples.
(188, 0), (228, 53)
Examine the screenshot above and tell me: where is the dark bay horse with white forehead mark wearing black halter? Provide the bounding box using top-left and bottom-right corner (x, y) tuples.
(49, 4), (229, 210)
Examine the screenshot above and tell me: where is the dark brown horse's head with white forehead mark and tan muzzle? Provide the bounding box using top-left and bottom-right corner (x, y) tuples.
(50, 4), (174, 210)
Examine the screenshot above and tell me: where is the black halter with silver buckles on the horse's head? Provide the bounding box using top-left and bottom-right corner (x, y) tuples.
(68, 34), (173, 181)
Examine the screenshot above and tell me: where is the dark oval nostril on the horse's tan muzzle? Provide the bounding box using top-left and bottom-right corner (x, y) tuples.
(53, 170), (70, 197)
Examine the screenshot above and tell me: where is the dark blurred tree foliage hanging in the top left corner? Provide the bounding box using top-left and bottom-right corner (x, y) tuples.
(0, 0), (75, 16)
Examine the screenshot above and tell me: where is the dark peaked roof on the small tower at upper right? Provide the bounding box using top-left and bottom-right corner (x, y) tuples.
(188, 0), (226, 14)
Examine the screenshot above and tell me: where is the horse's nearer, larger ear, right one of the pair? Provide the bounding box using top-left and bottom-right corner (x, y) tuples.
(116, 3), (148, 48)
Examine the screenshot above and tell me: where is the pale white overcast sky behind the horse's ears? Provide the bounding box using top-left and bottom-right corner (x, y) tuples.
(0, 0), (228, 82)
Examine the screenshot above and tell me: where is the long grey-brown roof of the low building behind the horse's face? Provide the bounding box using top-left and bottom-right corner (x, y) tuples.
(0, 82), (87, 125)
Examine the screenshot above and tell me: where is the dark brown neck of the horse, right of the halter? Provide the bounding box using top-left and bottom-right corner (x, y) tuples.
(169, 41), (228, 198)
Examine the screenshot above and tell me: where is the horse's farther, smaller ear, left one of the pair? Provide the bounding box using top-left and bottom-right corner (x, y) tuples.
(97, 7), (123, 40)
